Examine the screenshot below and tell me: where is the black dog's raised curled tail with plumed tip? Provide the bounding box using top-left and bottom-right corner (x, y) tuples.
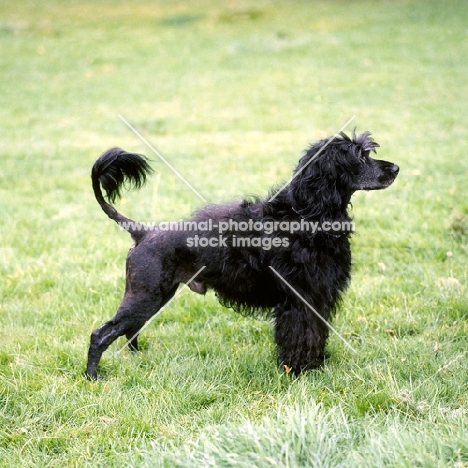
(91, 148), (153, 242)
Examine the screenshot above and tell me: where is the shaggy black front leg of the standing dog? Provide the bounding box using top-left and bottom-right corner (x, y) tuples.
(275, 300), (328, 375)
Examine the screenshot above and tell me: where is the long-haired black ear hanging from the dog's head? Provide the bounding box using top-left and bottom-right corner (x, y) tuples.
(288, 141), (347, 220)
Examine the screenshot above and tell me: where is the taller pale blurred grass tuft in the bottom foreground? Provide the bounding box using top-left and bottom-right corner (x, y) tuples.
(146, 399), (468, 468)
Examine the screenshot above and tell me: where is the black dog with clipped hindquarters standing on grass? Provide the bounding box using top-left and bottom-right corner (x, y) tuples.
(86, 132), (399, 379)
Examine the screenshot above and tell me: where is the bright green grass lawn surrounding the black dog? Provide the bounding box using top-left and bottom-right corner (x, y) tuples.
(0, 0), (468, 468)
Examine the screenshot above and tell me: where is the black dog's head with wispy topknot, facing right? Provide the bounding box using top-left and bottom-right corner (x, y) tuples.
(289, 132), (399, 219)
